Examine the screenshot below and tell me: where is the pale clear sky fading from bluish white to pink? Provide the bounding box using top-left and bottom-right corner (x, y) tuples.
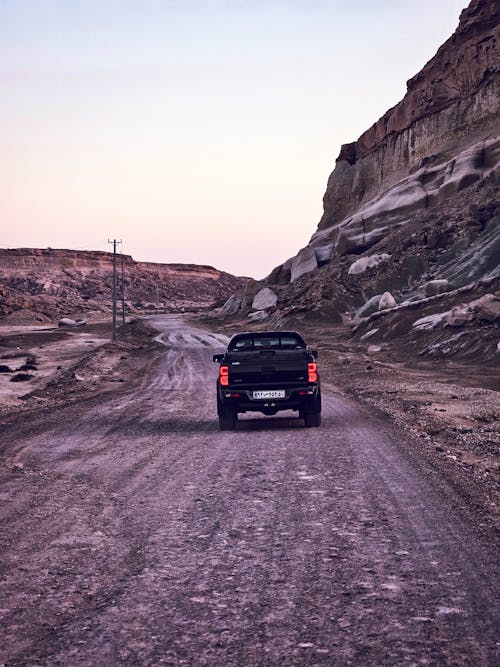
(0, 0), (467, 278)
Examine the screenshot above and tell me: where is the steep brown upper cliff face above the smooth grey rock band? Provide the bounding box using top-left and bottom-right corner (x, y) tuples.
(319, 0), (500, 235)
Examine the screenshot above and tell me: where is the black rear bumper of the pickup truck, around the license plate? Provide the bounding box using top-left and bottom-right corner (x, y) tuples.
(217, 383), (320, 414)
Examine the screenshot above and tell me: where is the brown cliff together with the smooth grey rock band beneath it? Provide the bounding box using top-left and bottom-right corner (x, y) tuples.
(270, 0), (500, 284)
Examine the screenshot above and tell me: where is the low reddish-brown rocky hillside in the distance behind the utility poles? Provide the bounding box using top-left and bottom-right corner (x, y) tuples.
(0, 248), (247, 323)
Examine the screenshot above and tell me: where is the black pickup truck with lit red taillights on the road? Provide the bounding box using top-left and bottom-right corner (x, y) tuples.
(213, 331), (321, 431)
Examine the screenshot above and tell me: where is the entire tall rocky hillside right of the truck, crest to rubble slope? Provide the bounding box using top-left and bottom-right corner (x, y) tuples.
(218, 0), (500, 356)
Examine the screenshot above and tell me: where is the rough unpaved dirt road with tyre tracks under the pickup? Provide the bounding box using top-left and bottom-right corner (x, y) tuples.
(0, 316), (499, 667)
